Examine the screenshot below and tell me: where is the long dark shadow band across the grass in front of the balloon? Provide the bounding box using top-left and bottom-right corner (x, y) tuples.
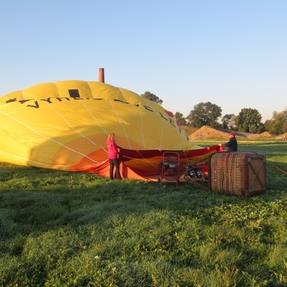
(0, 159), (287, 246)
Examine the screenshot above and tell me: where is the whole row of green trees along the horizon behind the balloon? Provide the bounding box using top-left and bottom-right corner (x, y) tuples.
(141, 92), (287, 135)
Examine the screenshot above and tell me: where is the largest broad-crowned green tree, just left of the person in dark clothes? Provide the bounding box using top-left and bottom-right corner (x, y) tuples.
(187, 102), (222, 127)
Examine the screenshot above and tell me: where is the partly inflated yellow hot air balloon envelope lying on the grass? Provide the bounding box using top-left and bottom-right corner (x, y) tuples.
(0, 81), (220, 181)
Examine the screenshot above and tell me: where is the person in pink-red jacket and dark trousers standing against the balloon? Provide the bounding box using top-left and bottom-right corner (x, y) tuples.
(107, 133), (121, 179)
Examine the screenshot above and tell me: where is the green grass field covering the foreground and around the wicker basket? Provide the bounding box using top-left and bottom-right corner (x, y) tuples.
(0, 142), (287, 287)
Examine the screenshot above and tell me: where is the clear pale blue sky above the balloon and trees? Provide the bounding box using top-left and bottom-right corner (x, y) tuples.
(0, 0), (287, 119)
